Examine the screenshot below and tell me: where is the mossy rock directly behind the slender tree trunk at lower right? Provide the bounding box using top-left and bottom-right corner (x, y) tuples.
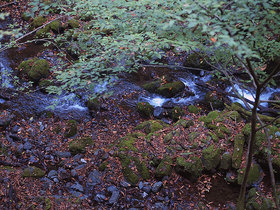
(237, 163), (263, 186)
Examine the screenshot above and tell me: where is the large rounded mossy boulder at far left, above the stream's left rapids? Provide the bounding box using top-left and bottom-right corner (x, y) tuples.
(27, 59), (50, 82)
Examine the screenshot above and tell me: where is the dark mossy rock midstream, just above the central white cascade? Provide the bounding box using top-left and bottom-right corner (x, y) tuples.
(157, 81), (185, 98)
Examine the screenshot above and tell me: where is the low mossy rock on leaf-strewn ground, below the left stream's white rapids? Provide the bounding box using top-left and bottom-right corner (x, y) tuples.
(69, 137), (94, 155)
